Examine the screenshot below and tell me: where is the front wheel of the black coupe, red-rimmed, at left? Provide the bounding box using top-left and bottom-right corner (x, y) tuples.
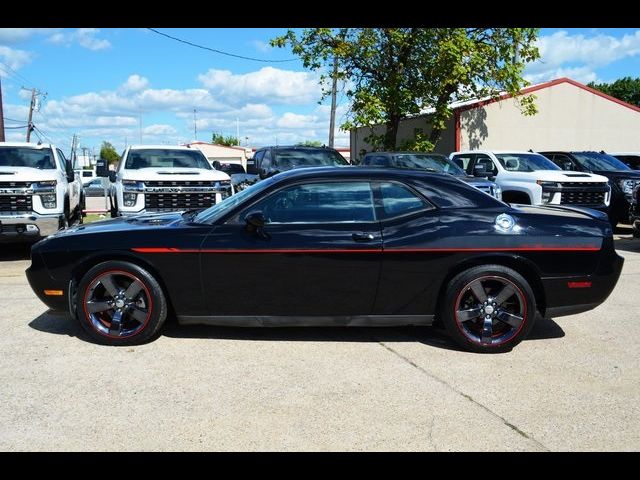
(76, 260), (167, 346)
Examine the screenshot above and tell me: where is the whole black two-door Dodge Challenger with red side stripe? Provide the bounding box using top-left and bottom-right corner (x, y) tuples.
(27, 167), (623, 352)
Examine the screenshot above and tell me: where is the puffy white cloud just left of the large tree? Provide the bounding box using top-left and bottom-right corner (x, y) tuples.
(198, 67), (321, 105)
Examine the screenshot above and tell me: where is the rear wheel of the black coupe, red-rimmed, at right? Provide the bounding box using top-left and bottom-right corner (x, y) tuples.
(438, 265), (537, 353)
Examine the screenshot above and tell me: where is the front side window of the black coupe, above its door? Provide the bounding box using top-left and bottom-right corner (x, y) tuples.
(245, 182), (375, 223)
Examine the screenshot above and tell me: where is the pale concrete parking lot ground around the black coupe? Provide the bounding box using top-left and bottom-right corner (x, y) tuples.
(0, 232), (640, 451)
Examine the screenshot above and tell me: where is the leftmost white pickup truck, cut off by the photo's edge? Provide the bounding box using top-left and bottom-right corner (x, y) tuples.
(0, 142), (84, 242)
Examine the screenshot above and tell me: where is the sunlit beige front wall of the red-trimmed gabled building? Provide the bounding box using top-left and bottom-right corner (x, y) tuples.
(460, 83), (640, 152)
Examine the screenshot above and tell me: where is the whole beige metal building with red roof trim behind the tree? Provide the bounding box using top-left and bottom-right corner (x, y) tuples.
(351, 78), (640, 158)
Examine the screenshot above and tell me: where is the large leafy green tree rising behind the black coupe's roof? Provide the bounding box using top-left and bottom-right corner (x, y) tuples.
(271, 28), (539, 149)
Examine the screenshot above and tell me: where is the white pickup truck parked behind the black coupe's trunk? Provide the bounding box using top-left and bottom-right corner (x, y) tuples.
(449, 150), (611, 212)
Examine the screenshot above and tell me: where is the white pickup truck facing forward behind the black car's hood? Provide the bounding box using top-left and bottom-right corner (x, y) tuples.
(110, 145), (234, 217)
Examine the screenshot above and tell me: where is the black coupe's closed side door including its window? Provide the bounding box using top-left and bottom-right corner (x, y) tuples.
(201, 180), (382, 316)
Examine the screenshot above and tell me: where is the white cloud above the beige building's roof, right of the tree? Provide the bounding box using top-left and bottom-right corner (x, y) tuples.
(525, 30), (640, 82)
